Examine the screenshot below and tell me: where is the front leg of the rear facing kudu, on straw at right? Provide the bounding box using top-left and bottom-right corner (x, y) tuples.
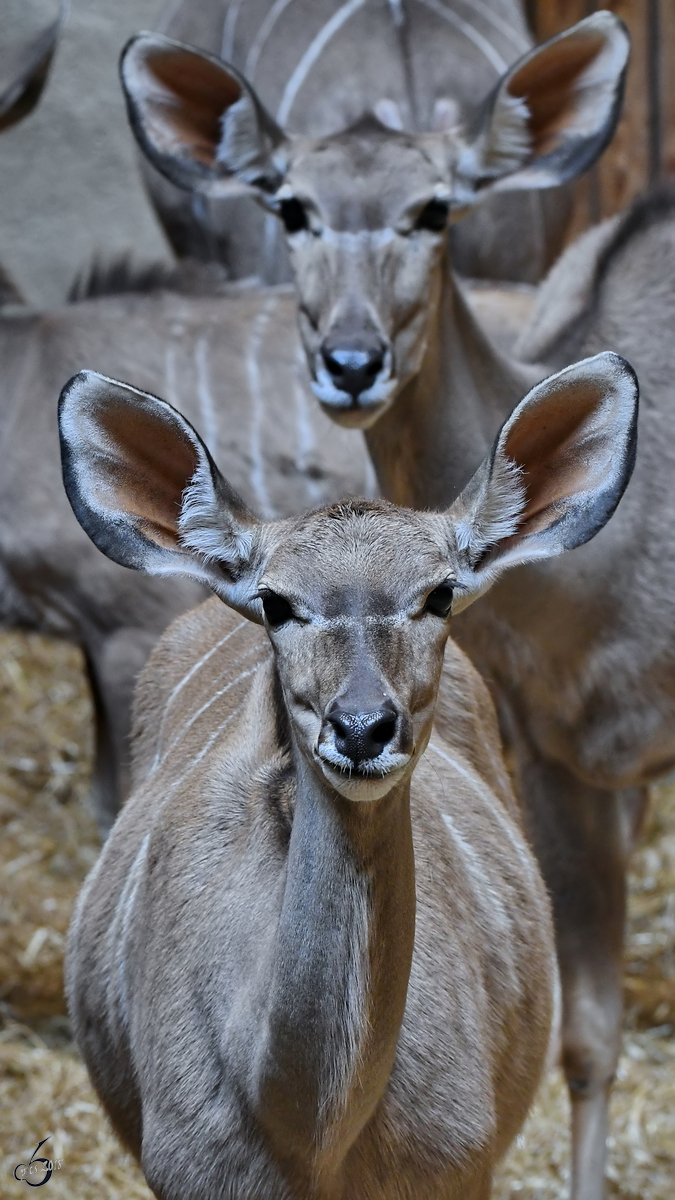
(509, 750), (644, 1200)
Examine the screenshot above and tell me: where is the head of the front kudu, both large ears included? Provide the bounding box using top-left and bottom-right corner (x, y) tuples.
(59, 353), (638, 800)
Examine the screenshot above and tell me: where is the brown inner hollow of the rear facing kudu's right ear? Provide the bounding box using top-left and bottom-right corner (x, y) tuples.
(508, 30), (607, 156)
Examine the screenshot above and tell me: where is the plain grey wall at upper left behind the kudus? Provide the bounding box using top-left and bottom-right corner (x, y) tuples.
(0, 0), (171, 306)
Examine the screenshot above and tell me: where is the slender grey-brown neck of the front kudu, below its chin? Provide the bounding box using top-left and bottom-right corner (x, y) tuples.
(258, 748), (414, 1180)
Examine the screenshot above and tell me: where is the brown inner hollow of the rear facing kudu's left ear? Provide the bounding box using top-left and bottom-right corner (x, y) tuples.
(144, 48), (241, 166)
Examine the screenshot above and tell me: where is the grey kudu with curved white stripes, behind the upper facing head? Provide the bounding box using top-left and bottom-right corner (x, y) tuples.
(145, 0), (569, 283)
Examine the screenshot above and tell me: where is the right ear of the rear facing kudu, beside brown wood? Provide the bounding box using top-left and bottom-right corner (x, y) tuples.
(458, 10), (631, 203)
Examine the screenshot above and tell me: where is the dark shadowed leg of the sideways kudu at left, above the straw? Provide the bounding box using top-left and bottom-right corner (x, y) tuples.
(85, 629), (156, 840)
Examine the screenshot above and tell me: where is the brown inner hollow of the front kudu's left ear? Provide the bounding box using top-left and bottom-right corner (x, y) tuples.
(97, 402), (198, 548)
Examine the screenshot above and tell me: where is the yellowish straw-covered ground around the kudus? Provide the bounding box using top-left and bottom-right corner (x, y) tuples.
(0, 634), (675, 1200)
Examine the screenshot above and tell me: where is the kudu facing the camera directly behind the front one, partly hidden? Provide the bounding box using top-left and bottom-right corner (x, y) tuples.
(123, 12), (638, 1200)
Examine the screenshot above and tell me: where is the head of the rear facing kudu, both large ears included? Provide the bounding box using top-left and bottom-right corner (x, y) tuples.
(121, 12), (629, 428)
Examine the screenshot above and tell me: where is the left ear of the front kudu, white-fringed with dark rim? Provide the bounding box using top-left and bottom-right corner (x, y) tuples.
(59, 371), (264, 622)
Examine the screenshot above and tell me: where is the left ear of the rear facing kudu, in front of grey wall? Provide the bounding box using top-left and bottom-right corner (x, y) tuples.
(120, 34), (283, 197)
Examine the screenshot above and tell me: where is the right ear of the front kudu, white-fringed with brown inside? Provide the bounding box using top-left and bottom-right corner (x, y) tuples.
(448, 353), (638, 612)
